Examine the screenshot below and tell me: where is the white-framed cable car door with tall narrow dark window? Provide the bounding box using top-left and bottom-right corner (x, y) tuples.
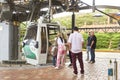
(37, 24), (48, 64)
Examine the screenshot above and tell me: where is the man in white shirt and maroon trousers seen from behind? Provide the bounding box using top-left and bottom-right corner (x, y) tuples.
(68, 27), (84, 75)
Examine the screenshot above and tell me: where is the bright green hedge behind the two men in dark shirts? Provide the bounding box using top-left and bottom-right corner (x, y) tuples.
(83, 33), (120, 49)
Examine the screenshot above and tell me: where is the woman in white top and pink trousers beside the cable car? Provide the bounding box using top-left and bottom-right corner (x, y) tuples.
(55, 33), (66, 69)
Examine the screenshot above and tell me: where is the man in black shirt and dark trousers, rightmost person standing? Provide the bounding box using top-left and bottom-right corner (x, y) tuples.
(89, 31), (97, 63)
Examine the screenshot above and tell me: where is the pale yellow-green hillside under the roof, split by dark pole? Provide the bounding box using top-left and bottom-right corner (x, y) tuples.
(53, 13), (107, 28)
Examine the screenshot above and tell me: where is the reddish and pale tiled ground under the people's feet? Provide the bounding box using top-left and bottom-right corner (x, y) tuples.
(0, 53), (120, 80)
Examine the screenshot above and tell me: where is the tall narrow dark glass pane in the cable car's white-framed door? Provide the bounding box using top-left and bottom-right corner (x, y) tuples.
(41, 27), (47, 54)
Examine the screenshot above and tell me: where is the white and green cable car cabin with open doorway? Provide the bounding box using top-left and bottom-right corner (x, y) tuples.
(22, 16), (65, 65)
